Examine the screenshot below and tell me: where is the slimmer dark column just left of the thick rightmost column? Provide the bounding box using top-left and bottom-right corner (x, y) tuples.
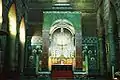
(97, 6), (106, 75)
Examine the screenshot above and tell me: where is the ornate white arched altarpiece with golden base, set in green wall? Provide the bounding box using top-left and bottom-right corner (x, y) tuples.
(48, 19), (76, 70)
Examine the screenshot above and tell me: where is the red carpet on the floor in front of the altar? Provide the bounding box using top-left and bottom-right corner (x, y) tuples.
(52, 70), (73, 78)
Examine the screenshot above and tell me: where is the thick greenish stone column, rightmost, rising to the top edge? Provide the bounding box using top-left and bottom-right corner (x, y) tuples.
(104, 0), (116, 78)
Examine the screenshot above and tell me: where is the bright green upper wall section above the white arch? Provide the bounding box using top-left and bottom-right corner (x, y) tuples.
(43, 11), (81, 30)
